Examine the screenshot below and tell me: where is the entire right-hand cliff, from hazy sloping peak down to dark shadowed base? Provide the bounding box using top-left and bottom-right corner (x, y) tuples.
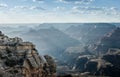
(71, 28), (120, 77)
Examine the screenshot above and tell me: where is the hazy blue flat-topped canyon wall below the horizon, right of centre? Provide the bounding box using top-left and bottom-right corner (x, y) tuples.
(65, 23), (116, 44)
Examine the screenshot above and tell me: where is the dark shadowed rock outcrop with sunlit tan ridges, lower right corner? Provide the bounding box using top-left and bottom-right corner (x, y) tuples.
(75, 43), (120, 77)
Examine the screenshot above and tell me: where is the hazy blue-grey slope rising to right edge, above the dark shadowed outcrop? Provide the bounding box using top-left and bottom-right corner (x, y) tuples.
(95, 27), (120, 54)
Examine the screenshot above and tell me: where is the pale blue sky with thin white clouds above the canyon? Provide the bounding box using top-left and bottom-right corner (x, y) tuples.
(0, 0), (120, 23)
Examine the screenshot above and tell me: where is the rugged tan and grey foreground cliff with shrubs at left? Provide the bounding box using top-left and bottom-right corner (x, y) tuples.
(0, 32), (56, 77)
